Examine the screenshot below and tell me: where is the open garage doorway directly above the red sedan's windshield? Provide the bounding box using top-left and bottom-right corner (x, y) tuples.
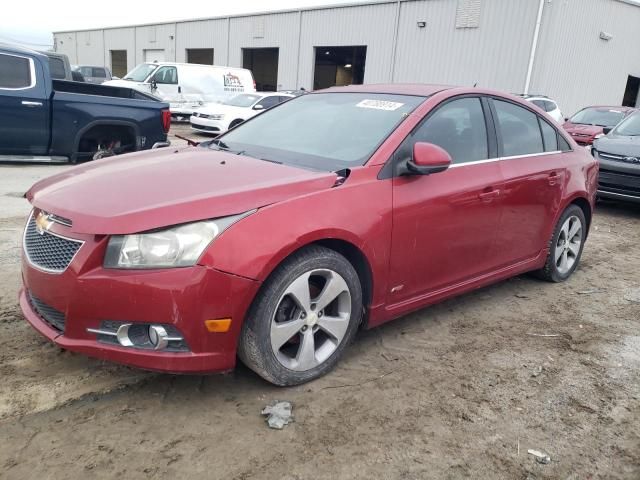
(313, 46), (367, 90)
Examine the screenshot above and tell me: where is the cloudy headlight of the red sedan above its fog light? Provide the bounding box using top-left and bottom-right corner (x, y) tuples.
(104, 214), (250, 269)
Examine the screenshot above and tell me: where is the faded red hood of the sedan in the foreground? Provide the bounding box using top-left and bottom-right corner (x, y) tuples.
(26, 147), (337, 234)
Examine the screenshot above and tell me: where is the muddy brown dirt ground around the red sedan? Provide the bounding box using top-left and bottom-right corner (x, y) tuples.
(0, 136), (640, 480)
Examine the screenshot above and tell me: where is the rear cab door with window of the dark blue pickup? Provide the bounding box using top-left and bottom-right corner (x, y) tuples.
(0, 53), (50, 155)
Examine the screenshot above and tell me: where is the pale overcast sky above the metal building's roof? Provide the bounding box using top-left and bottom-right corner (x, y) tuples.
(0, 0), (364, 49)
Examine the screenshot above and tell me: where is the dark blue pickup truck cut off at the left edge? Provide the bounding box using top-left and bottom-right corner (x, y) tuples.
(0, 44), (171, 162)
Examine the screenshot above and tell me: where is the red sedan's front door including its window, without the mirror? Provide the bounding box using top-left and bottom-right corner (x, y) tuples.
(388, 97), (503, 304)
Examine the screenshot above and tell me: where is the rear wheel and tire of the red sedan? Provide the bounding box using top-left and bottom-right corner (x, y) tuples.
(534, 205), (587, 283)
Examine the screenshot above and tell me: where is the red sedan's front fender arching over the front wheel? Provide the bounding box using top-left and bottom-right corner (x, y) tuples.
(199, 167), (392, 303)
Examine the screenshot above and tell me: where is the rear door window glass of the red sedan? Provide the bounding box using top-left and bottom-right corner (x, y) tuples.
(493, 100), (544, 157)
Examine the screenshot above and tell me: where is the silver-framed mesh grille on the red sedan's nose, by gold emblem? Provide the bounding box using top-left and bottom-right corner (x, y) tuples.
(24, 214), (83, 273)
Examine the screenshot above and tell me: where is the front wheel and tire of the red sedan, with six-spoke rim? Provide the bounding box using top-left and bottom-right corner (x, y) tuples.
(238, 246), (363, 386)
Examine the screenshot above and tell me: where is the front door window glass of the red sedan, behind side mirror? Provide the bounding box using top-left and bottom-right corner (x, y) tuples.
(411, 98), (489, 163)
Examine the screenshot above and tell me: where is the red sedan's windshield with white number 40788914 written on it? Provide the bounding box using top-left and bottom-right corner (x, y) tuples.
(214, 93), (425, 171)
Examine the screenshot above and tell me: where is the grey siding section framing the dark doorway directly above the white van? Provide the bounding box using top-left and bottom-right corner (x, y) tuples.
(176, 18), (229, 65)
